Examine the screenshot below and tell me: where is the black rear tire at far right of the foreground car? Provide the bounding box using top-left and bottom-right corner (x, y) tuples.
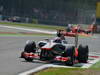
(78, 45), (89, 63)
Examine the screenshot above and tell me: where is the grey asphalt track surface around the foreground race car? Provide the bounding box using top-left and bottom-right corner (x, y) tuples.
(0, 25), (100, 75)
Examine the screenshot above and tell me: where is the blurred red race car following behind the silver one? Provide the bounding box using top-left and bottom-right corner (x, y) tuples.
(63, 24), (97, 36)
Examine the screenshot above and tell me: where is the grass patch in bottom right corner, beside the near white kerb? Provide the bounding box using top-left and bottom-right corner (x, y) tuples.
(31, 68), (100, 75)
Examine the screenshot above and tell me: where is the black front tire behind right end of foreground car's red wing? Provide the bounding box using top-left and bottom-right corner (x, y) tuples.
(62, 46), (75, 66)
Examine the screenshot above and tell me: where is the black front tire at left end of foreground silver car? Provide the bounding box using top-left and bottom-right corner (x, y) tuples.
(24, 41), (36, 53)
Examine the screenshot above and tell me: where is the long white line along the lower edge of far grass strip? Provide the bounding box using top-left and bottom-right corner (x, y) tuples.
(0, 25), (56, 34)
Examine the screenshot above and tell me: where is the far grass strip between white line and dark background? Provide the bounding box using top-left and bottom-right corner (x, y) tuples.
(0, 22), (65, 30)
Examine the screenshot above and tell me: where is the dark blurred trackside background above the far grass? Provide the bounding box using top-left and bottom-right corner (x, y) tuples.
(0, 0), (100, 25)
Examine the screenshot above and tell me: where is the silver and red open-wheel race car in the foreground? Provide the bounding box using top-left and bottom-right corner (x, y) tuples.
(21, 33), (89, 66)
